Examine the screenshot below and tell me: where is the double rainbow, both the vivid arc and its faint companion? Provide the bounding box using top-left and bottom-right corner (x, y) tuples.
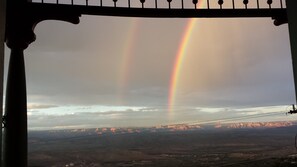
(118, 0), (205, 112)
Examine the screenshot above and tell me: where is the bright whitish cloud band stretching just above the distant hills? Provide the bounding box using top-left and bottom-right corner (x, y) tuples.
(28, 106), (296, 129)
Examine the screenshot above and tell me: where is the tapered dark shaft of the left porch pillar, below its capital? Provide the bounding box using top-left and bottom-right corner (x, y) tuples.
(3, 46), (28, 167)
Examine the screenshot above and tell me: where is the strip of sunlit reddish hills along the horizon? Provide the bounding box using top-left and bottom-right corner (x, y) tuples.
(30, 122), (297, 138)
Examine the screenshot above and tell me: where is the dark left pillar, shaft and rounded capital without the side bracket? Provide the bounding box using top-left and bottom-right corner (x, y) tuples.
(3, 2), (35, 167)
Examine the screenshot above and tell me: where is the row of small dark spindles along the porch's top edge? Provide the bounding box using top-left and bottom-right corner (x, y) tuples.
(32, 0), (285, 9)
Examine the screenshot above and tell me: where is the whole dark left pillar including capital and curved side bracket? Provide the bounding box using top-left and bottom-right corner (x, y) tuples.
(3, 1), (80, 167)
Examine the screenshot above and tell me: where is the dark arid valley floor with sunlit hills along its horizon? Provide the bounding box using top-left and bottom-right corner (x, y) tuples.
(29, 123), (297, 167)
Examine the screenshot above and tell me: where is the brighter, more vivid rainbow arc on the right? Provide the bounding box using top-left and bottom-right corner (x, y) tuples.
(168, 0), (205, 113)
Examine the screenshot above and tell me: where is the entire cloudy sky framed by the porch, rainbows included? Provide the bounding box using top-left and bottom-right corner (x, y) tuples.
(5, 0), (297, 129)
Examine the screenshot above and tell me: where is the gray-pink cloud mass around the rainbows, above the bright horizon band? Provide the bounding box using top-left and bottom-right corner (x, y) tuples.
(23, 17), (294, 106)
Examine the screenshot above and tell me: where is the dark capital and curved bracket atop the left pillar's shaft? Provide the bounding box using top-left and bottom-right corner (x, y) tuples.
(5, 1), (80, 50)
